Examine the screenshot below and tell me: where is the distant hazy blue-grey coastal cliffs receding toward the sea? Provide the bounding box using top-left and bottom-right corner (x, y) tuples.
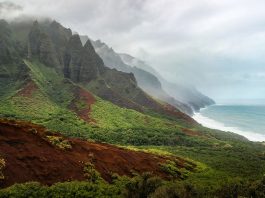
(89, 37), (214, 115)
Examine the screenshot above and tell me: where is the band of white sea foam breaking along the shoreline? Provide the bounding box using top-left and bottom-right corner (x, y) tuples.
(193, 113), (265, 142)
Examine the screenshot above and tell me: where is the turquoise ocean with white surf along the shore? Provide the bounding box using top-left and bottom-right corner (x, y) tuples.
(193, 104), (265, 141)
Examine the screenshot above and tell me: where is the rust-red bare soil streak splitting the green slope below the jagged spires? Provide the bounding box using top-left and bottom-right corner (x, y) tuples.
(69, 87), (96, 122)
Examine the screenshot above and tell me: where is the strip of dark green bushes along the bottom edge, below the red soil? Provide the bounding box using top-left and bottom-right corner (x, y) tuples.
(0, 173), (265, 198)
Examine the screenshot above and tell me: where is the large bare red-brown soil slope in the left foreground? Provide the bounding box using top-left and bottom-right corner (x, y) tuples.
(0, 120), (195, 187)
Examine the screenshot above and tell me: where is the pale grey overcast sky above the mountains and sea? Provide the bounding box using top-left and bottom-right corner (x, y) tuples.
(0, 0), (265, 101)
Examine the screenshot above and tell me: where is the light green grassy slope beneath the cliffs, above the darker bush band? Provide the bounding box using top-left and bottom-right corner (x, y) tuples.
(0, 61), (190, 140)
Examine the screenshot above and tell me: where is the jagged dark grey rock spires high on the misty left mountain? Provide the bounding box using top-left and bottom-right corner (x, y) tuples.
(28, 21), (104, 83)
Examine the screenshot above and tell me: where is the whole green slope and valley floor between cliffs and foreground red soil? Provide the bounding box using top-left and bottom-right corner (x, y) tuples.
(0, 61), (265, 192)
